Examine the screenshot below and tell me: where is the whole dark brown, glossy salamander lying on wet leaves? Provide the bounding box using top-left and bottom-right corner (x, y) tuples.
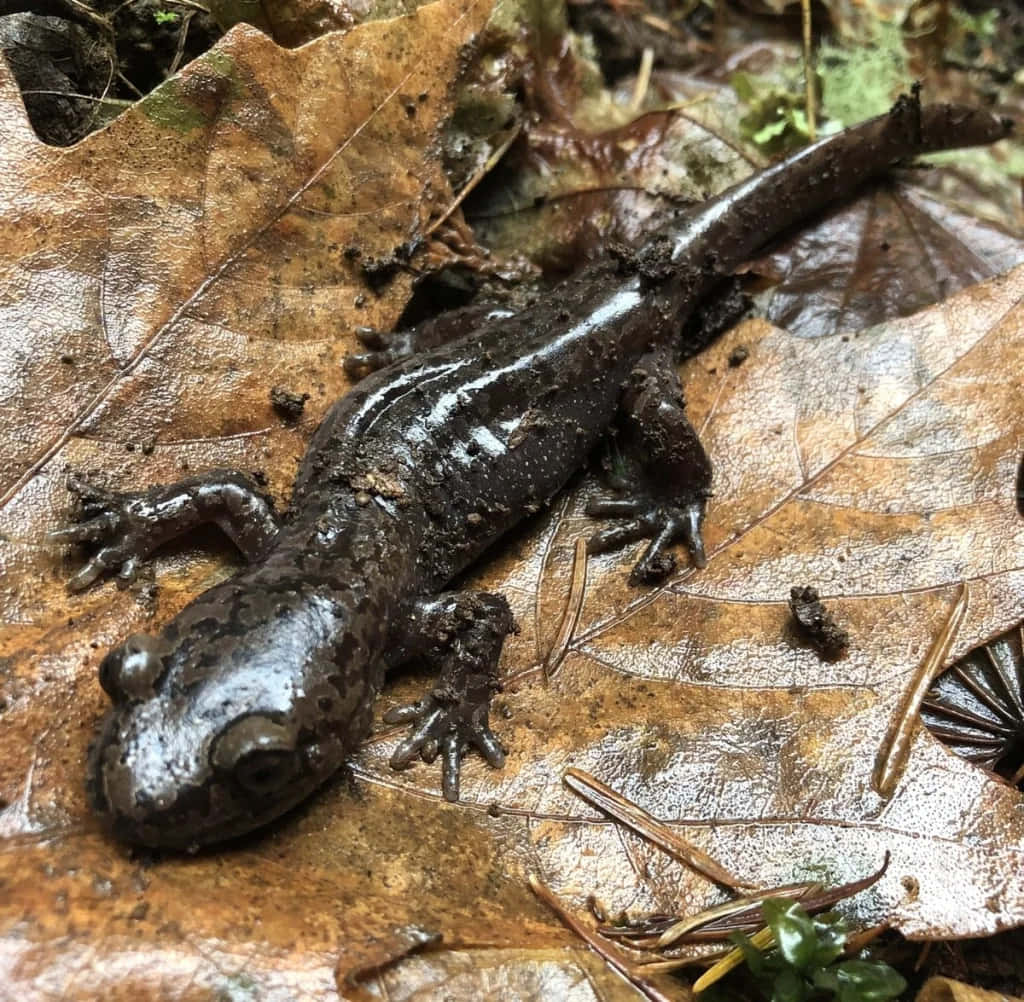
(52, 95), (1010, 849)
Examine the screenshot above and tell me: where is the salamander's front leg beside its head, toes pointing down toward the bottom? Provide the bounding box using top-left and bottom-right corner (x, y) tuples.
(384, 592), (515, 801)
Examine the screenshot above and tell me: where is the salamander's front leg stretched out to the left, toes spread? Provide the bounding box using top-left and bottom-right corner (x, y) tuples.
(48, 470), (278, 592)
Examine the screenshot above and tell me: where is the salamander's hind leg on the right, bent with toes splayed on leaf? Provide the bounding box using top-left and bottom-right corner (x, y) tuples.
(587, 351), (712, 584)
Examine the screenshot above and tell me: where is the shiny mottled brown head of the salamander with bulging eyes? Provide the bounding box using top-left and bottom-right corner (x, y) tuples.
(87, 582), (379, 849)
